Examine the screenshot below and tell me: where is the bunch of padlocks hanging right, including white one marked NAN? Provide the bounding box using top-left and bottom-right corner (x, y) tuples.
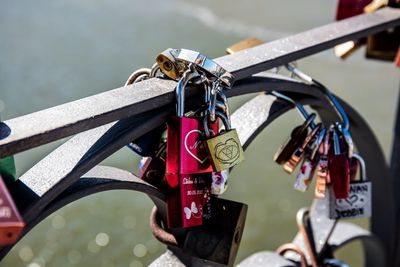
(273, 65), (372, 219)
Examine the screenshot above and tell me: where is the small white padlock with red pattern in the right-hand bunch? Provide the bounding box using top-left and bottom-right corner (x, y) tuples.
(294, 128), (326, 192)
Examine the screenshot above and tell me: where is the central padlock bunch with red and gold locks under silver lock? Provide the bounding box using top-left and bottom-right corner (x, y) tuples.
(127, 49), (244, 228)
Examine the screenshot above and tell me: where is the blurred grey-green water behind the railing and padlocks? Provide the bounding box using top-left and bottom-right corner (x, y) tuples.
(0, 0), (399, 267)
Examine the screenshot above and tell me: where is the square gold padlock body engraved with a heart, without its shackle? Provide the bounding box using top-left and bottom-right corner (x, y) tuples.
(205, 129), (244, 172)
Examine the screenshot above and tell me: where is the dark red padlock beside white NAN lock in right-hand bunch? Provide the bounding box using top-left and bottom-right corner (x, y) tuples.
(328, 128), (350, 198)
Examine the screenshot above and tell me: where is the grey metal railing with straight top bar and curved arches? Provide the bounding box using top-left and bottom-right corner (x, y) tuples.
(0, 8), (400, 266)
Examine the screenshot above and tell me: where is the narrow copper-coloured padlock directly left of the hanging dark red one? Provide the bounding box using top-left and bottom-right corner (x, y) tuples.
(314, 129), (331, 198)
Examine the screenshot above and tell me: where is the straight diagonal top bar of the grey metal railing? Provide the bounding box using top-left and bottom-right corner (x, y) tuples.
(0, 8), (400, 158)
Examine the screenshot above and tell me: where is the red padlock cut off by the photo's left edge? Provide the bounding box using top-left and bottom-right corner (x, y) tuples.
(0, 175), (25, 246)
